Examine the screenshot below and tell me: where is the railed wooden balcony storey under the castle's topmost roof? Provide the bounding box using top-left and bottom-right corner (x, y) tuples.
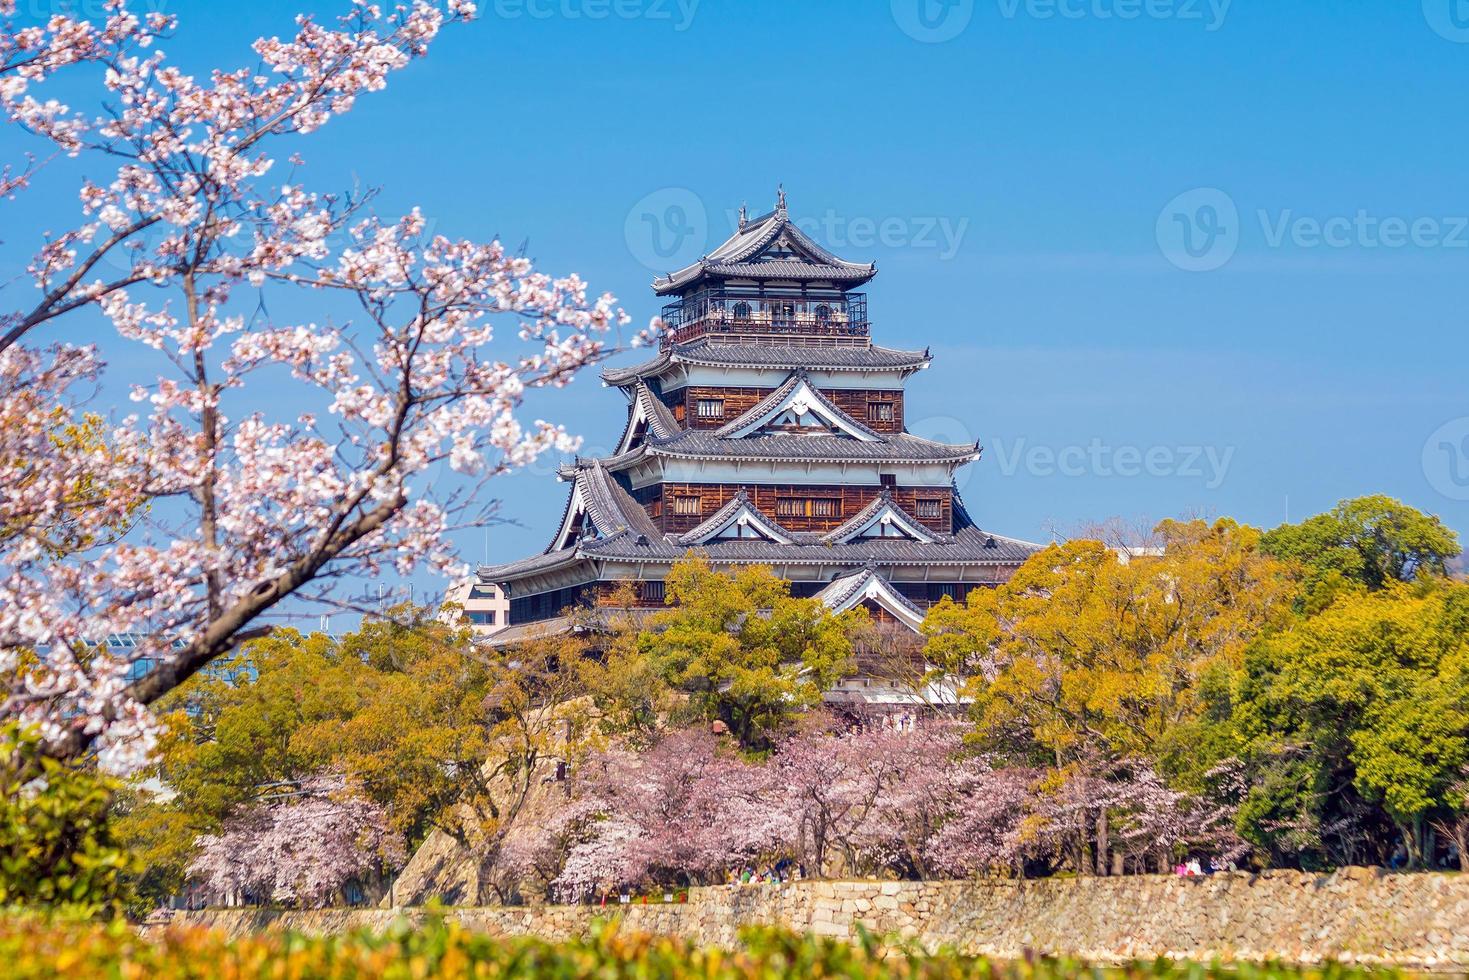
(663, 289), (868, 347)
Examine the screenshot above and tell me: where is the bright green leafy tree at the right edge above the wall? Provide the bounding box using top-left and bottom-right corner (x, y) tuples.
(1237, 580), (1469, 865)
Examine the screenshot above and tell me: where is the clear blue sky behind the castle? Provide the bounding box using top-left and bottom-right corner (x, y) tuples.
(6, 0), (1469, 614)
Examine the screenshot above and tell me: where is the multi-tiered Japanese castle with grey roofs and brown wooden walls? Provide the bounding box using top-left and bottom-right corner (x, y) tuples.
(479, 194), (1039, 641)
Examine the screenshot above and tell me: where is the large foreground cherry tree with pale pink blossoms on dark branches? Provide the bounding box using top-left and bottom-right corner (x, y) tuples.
(0, 0), (646, 770)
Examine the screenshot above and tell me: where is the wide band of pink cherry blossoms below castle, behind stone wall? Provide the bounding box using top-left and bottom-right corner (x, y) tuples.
(540, 720), (1238, 899)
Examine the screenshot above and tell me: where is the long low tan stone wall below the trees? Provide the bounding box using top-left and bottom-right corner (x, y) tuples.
(177, 868), (1469, 968)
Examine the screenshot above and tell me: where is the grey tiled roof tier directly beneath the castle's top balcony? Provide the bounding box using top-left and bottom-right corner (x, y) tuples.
(602, 338), (931, 388)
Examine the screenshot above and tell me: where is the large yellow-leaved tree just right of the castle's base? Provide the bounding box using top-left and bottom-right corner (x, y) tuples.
(924, 520), (1296, 873)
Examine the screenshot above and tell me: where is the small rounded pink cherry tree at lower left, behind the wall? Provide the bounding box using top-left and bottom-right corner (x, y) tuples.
(190, 776), (405, 907)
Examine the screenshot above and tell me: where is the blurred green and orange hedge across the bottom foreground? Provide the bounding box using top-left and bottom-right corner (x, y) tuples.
(0, 917), (1398, 980)
